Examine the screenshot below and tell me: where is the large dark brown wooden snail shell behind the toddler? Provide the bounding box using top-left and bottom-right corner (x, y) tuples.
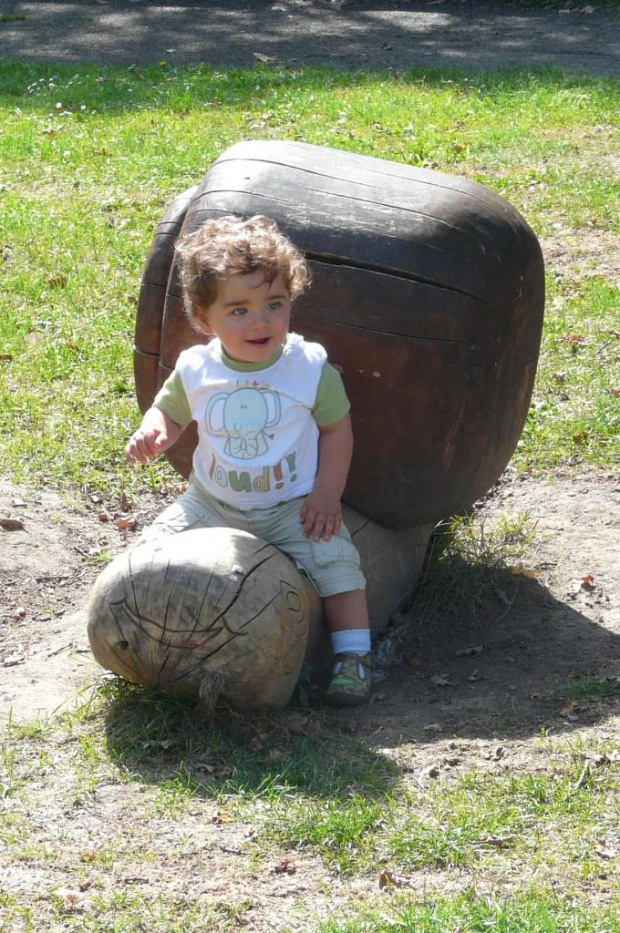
(136, 141), (544, 529)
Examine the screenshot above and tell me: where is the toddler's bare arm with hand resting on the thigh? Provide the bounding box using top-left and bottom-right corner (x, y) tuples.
(299, 414), (353, 541)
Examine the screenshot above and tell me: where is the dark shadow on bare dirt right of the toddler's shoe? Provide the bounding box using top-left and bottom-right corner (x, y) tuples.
(348, 571), (620, 746)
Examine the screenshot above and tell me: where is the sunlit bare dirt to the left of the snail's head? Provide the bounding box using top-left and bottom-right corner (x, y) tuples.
(0, 482), (176, 721)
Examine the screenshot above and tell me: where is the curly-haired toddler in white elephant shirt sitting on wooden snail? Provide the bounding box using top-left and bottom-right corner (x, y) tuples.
(126, 216), (371, 706)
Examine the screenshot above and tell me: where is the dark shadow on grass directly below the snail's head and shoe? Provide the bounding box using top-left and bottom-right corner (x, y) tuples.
(101, 678), (398, 802)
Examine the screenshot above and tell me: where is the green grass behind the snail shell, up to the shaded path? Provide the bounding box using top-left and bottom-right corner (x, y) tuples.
(0, 64), (620, 492)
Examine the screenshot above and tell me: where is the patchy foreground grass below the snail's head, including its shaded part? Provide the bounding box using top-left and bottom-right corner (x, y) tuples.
(0, 679), (620, 933)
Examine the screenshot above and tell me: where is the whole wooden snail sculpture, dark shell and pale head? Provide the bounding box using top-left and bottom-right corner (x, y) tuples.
(88, 141), (544, 708)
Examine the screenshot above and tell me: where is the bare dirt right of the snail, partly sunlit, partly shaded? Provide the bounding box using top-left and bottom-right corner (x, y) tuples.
(344, 470), (620, 766)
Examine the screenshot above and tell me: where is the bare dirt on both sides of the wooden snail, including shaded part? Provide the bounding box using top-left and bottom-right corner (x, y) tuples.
(0, 470), (620, 748)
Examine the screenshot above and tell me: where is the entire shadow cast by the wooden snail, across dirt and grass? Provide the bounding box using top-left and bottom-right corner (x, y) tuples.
(101, 560), (620, 799)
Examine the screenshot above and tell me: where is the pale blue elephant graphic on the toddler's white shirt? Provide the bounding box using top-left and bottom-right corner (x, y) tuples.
(205, 387), (282, 460)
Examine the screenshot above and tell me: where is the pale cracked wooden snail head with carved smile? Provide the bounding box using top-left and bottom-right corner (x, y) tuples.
(88, 528), (320, 709)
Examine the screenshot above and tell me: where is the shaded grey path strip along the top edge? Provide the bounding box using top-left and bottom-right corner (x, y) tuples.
(0, 0), (620, 75)
